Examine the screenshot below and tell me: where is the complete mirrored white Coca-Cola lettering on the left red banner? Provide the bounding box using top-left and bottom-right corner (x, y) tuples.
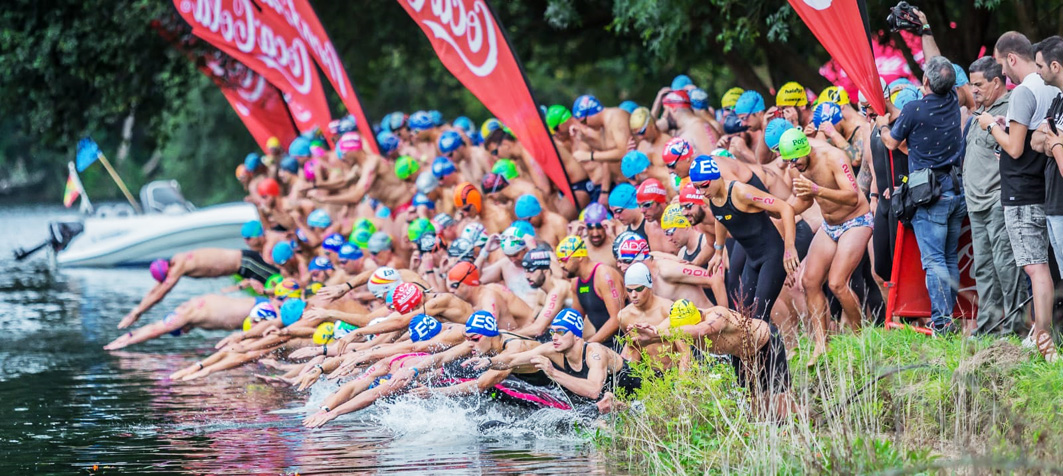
(179, 0), (314, 95)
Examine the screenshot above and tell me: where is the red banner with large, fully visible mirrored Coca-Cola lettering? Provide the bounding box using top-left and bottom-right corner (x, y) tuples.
(173, 0), (332, 138)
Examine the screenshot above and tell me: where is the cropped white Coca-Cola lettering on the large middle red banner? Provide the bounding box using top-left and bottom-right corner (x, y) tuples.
(407, 0), (499, 78)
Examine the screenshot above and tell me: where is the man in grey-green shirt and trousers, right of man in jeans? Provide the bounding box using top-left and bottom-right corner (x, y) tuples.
(963, 56), (1027, 336)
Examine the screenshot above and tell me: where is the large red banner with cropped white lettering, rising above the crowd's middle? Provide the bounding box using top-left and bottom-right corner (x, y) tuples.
(399, 0), (575, 203)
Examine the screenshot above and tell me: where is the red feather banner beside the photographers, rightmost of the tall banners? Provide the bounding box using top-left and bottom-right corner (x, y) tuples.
(790, 0), (885, 115)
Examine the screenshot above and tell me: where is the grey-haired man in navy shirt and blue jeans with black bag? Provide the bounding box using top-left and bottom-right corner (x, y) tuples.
(875, 56), (967, 335)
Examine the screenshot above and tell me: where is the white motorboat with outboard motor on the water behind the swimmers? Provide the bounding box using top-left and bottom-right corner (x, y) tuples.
(42, 181), (258, 267)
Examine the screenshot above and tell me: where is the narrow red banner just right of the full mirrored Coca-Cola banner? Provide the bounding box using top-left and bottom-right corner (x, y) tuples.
(254, 0), (379, 153)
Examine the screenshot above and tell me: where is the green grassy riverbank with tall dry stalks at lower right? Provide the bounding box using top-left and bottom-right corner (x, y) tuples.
(596, 329), (1063, 474)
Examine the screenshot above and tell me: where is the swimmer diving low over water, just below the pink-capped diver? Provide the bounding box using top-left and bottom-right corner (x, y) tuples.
(103, 294), (265, 351)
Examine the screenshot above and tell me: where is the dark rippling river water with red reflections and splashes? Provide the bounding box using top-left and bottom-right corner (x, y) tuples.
(0, 206), (619, 475)
